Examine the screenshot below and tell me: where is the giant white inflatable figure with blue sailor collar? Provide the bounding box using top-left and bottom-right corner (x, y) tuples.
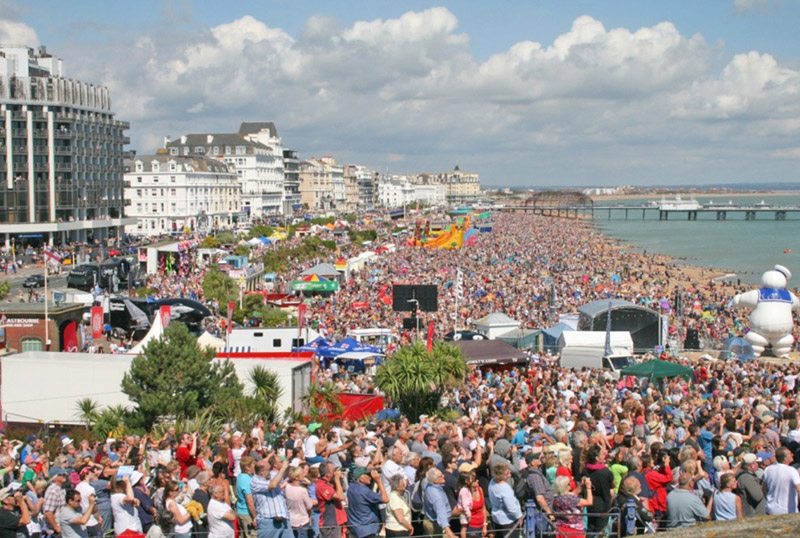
(733, 265), (800, 357)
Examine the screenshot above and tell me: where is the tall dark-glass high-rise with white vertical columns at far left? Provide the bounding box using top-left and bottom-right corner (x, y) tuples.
(0, 45), (136, 248)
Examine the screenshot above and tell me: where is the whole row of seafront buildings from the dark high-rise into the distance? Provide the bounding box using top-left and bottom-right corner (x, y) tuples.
(0, 45), (480, 244)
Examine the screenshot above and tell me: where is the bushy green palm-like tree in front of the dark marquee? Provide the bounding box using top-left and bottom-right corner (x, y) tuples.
(375, 341), (467, 417)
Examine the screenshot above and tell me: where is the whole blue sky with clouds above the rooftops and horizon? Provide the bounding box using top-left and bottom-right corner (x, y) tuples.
(0, 0), (800, 188)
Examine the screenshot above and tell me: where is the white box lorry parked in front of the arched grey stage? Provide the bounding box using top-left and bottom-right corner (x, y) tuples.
(558, 331), (636, 378)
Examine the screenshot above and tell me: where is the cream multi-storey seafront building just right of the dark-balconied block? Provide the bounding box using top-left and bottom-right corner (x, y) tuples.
(300, 157), (347, 211)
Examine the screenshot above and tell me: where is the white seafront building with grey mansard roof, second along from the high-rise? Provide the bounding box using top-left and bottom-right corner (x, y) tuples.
(164, 133), (284, 222)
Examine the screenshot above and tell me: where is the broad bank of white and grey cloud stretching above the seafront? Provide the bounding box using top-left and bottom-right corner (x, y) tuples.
(10, 6), (800, 183)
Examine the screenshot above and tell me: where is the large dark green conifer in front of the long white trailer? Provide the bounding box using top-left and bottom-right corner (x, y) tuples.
(122, 322), (243, 430)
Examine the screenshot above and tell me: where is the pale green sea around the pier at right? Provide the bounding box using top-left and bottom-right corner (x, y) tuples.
(594, 193), (800, 287)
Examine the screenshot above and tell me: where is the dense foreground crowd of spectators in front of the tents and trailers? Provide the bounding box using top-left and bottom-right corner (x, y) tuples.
(0, 348), (800, 538)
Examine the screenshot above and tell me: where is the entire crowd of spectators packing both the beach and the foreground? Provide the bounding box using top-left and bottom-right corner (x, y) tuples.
(0, 214), (800, 538)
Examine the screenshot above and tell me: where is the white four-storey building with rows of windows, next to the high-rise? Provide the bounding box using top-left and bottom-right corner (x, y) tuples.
(125, 150), (242, 236)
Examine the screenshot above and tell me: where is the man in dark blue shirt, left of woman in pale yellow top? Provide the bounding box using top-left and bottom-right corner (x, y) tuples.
(347, 467), (389, 538)
